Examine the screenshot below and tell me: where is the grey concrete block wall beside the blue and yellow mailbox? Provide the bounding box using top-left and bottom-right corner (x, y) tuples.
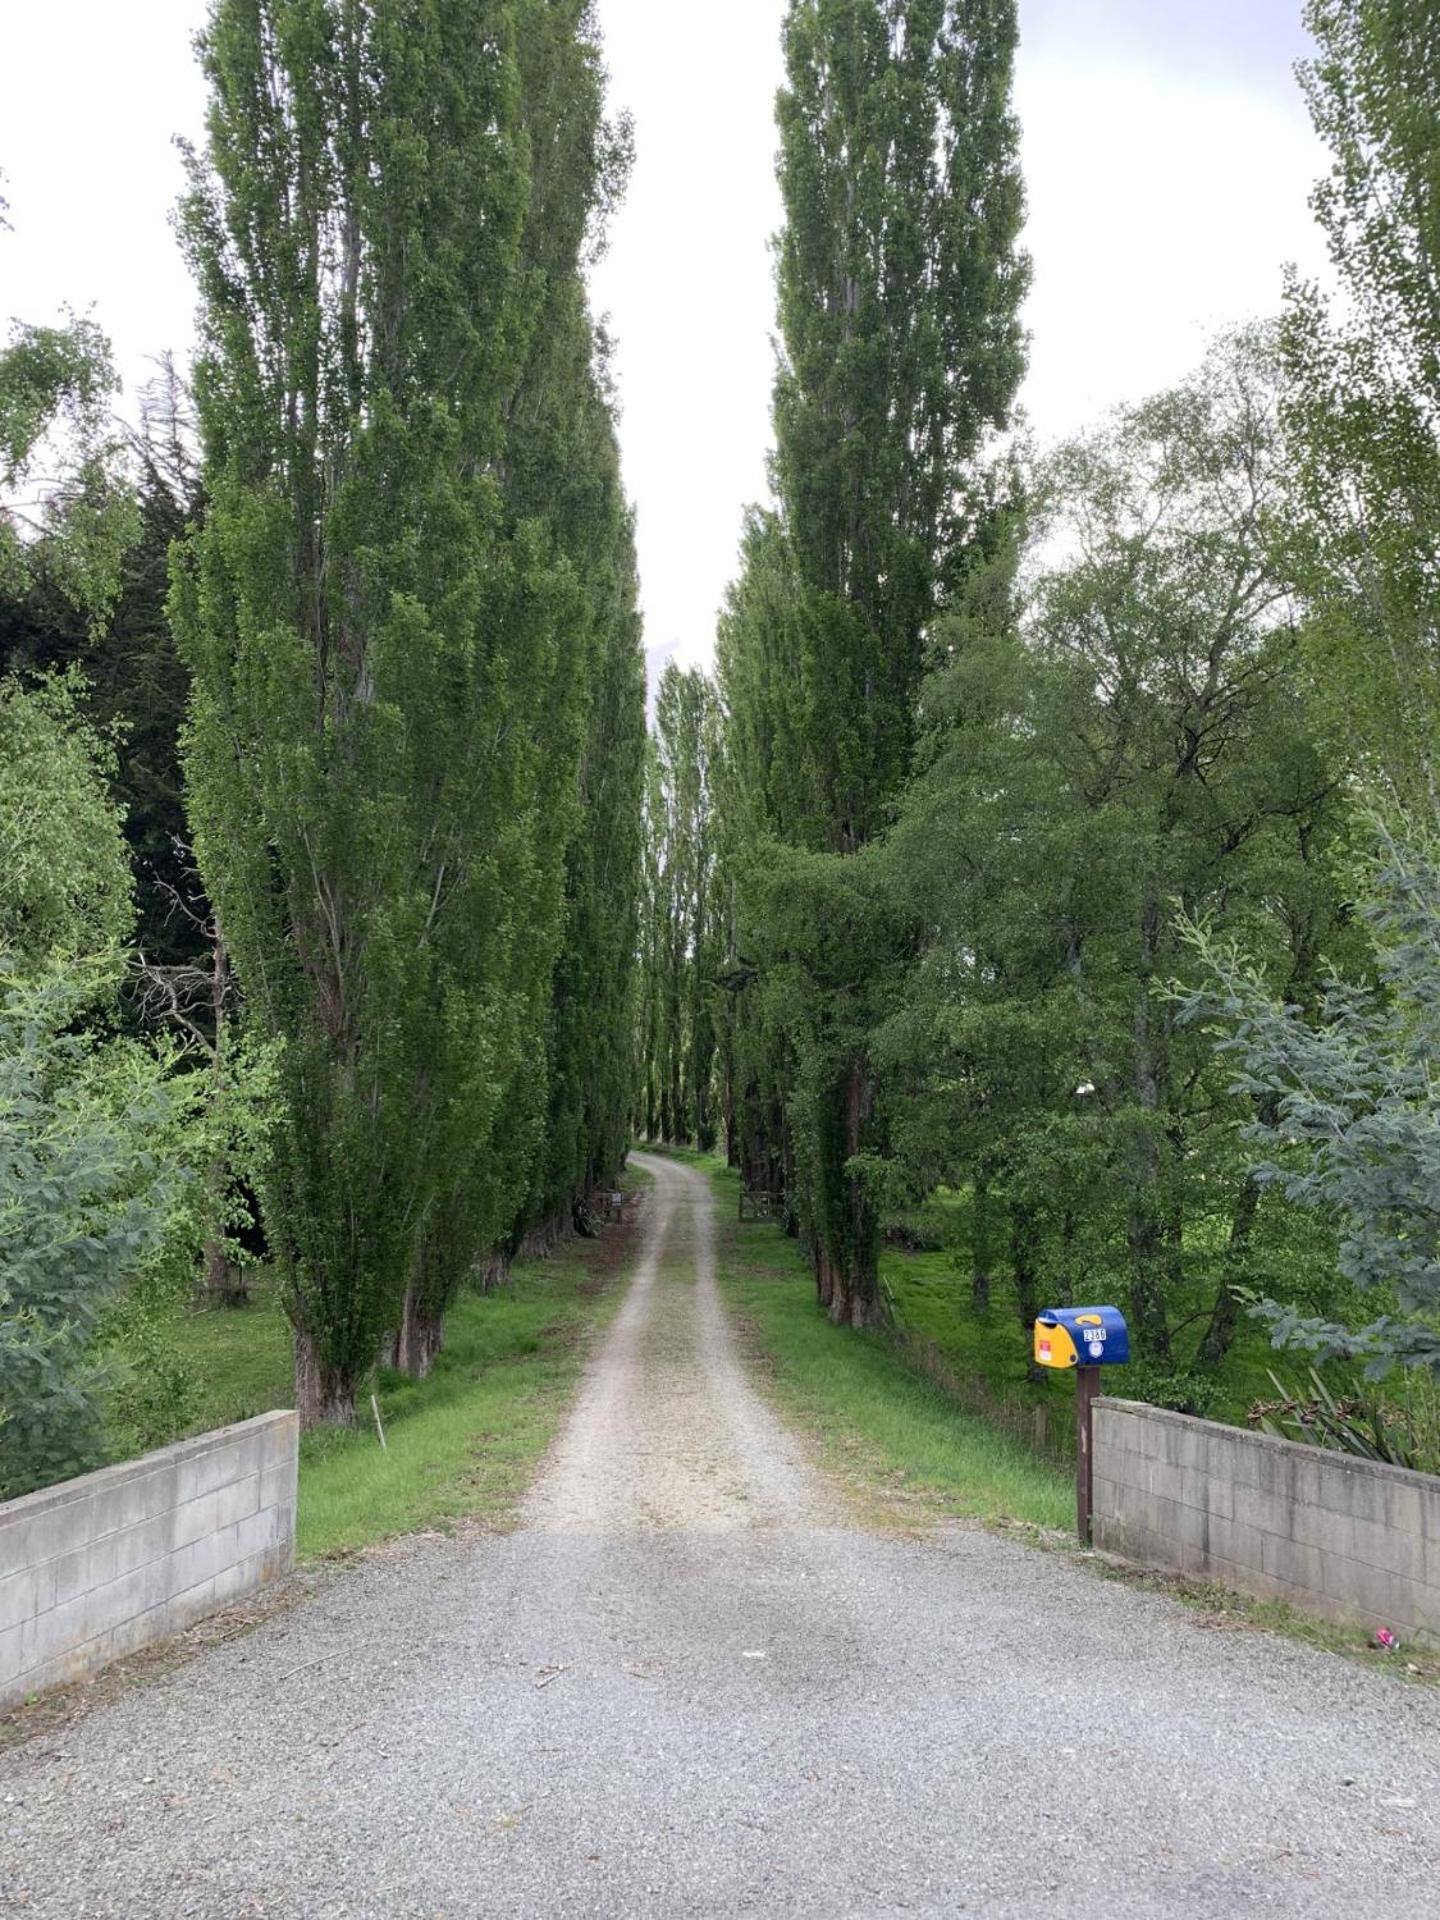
(1092, 1400), (1440, 1645)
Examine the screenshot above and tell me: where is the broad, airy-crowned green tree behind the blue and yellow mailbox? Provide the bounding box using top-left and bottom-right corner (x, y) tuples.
(876, 334), (1354, 1375)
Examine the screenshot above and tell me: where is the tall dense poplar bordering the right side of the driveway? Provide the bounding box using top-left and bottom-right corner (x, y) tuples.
(720, 0), (1025, 1325)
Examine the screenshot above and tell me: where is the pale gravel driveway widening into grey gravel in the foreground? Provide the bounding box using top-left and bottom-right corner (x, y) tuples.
(0, 1160), (1440, 1920)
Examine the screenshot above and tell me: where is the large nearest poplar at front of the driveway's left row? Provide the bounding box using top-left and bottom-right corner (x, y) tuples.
(173, 0), (559, 1421)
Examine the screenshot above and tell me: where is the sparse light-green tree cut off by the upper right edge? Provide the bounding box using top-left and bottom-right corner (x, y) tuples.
(1284, 0), (1440, 818)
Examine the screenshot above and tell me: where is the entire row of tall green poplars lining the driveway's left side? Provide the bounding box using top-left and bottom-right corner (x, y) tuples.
(173, 0), (641, 1421)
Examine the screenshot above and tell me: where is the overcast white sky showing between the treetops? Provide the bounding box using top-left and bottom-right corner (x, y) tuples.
(0, 0), (1325, 691)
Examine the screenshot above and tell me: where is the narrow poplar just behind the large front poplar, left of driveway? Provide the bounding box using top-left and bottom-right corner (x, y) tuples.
(499, 0), (645, 1267)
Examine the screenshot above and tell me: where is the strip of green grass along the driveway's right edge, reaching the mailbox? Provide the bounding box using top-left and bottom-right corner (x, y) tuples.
(674, 1152), (1075, 1528)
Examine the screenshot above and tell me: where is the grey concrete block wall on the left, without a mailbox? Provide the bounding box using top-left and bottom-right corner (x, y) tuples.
(0, 1413), (300, 1709)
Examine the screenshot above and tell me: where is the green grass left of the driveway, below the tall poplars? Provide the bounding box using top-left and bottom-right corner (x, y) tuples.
(166, 1173), (645, 1559)
